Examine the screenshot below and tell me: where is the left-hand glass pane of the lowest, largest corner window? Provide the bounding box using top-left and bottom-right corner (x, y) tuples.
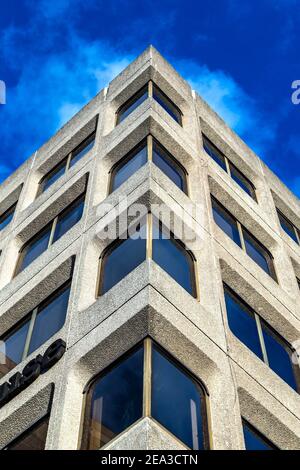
(87, 347), (144, 449)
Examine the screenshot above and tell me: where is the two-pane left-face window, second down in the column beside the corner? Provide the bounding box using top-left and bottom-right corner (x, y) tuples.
(15, 195), (85, 275)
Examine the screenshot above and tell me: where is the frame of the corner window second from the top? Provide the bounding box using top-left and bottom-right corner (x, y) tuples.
(107, 134), (190, 197)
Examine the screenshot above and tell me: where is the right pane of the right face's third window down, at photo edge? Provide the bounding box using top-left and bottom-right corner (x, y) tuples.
(261, 322), (297, 391)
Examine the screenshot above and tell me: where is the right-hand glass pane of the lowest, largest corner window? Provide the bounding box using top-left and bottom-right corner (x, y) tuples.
(151, 346), (204, 450)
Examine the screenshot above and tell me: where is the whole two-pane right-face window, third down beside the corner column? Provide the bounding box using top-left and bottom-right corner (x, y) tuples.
(224, 286), (299, 391)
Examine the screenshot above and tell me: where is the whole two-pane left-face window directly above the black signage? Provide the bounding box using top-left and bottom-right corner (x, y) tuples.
(0, 281), (70, 378)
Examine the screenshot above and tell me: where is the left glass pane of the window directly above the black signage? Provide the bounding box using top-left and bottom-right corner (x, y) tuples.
(0, 320), (29, 378)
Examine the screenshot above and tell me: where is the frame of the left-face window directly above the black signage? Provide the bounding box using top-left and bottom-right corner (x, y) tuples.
(0, 276), (72, 380)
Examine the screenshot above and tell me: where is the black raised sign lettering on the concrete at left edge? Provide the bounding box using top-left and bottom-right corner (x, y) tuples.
(0, 339), (66, 408)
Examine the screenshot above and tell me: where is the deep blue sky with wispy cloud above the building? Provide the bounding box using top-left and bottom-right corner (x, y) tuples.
(0, 0), (300, 197)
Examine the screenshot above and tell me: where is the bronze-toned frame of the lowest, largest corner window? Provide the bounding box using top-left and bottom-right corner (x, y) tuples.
(79, 336), (213, 450)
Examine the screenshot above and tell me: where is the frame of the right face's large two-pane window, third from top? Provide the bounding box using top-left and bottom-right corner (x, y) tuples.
(223, 282), (300, 394)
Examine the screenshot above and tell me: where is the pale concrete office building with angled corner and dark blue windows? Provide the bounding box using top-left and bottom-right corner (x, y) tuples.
(0, 47), (300, 450)
